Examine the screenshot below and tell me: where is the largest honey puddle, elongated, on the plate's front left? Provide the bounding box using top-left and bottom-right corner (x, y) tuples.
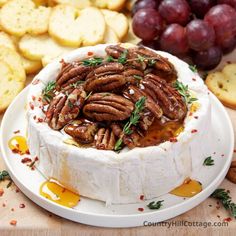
(39, 180), (80, 208)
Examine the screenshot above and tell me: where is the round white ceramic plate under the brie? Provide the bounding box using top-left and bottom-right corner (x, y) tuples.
(0, 88), (234, 227)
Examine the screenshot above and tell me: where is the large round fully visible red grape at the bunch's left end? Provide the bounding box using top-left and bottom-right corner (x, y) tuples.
(132, 8), (164, 41)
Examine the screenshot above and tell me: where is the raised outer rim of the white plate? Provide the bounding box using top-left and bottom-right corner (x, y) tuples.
(0, 85), (234, 228)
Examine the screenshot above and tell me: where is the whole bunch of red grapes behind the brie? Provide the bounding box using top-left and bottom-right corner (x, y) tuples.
(132, 0), (236, 70)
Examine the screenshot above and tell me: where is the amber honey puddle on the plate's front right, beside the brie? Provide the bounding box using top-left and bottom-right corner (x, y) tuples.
(170, 178), (202, 197)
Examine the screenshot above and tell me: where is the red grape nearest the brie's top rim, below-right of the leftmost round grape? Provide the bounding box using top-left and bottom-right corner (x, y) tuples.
(160, 24), (188, 55)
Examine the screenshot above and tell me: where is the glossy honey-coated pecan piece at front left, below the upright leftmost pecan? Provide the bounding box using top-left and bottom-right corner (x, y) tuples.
(64, 119), (97, 144)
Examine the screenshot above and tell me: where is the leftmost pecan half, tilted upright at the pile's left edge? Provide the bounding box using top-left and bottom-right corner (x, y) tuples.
(46, 87), (86, 130)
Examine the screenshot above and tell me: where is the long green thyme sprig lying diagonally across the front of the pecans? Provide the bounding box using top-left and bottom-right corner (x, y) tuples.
(114, 97), (146, 151)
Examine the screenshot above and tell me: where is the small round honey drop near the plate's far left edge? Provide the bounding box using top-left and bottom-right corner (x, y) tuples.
(8, 135), (29, 155)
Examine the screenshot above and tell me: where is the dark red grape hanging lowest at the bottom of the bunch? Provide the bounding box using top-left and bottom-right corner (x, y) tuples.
(193, 46), (222, 70)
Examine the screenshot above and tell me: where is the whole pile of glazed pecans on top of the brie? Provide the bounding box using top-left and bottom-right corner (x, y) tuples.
(44, 45), (187, 150)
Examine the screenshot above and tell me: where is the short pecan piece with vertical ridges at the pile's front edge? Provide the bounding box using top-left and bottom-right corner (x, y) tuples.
(95, 128), (116, 150)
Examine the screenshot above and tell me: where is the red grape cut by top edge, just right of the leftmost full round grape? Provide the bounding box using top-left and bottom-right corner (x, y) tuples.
(158, 0), (190, 25)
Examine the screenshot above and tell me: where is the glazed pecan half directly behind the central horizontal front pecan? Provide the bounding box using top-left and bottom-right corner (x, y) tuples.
(85, 62), (126, 92)
